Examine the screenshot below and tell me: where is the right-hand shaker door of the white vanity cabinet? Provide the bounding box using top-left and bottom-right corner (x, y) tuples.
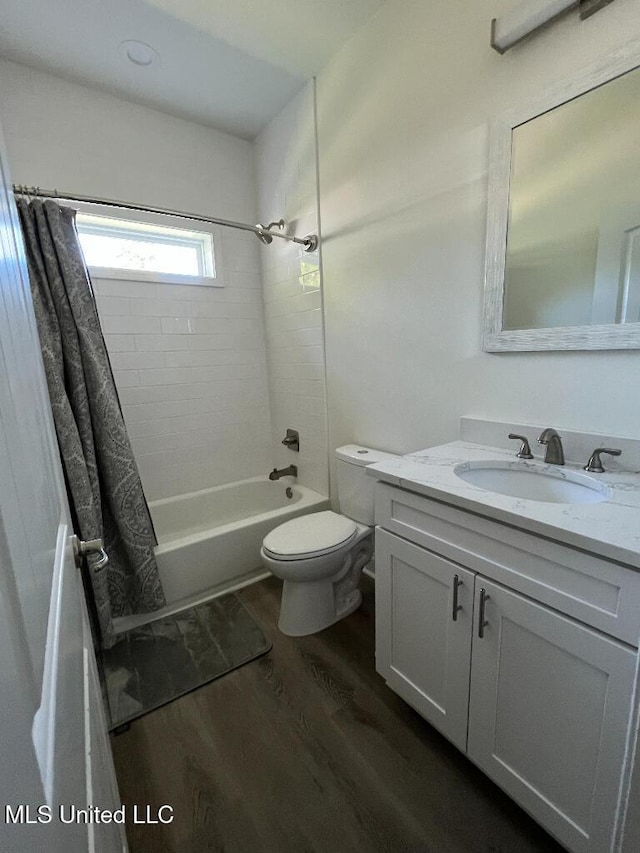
(467, 576), (636, 853)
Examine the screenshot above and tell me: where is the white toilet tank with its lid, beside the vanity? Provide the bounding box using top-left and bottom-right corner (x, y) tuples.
(336, 444), (397, 525)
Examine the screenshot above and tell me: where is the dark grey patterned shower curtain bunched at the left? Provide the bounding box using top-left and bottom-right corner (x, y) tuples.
(17, 199), (165, 648)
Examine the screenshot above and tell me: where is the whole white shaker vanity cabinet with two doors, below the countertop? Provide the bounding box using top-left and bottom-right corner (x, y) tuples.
(376, 484), (640, 853)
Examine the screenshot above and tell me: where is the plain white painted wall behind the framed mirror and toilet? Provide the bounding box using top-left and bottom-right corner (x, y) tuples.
(318, 0), (640, 490)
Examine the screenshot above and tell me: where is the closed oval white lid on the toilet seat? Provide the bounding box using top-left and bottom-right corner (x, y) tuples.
(263, 510), (357, 560)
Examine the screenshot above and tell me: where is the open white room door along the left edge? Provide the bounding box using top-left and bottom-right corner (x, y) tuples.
(0, 123), (126, 853)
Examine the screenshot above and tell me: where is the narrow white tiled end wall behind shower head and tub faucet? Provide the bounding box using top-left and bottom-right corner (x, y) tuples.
(255, 84), (328, 494)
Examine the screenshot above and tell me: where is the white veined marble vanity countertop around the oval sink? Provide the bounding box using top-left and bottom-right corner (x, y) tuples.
(367, 441), (640, 569)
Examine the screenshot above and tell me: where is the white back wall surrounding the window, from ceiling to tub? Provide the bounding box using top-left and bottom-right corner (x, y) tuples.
(0, 61), (271, 499)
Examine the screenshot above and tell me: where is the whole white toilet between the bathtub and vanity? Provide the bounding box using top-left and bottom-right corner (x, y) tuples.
(260, 444), (395, 637)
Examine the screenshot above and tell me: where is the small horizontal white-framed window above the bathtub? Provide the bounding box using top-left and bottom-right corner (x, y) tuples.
(75, 204), (223, 287)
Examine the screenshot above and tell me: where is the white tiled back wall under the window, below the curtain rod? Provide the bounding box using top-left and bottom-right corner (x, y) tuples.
(93, 226), (271, 500)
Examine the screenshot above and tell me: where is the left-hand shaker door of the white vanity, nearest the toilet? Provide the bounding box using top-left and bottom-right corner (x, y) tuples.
(376, 528), (475, 750)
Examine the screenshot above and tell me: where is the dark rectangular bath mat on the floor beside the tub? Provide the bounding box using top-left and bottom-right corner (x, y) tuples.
(102, 594), (271, 730)
